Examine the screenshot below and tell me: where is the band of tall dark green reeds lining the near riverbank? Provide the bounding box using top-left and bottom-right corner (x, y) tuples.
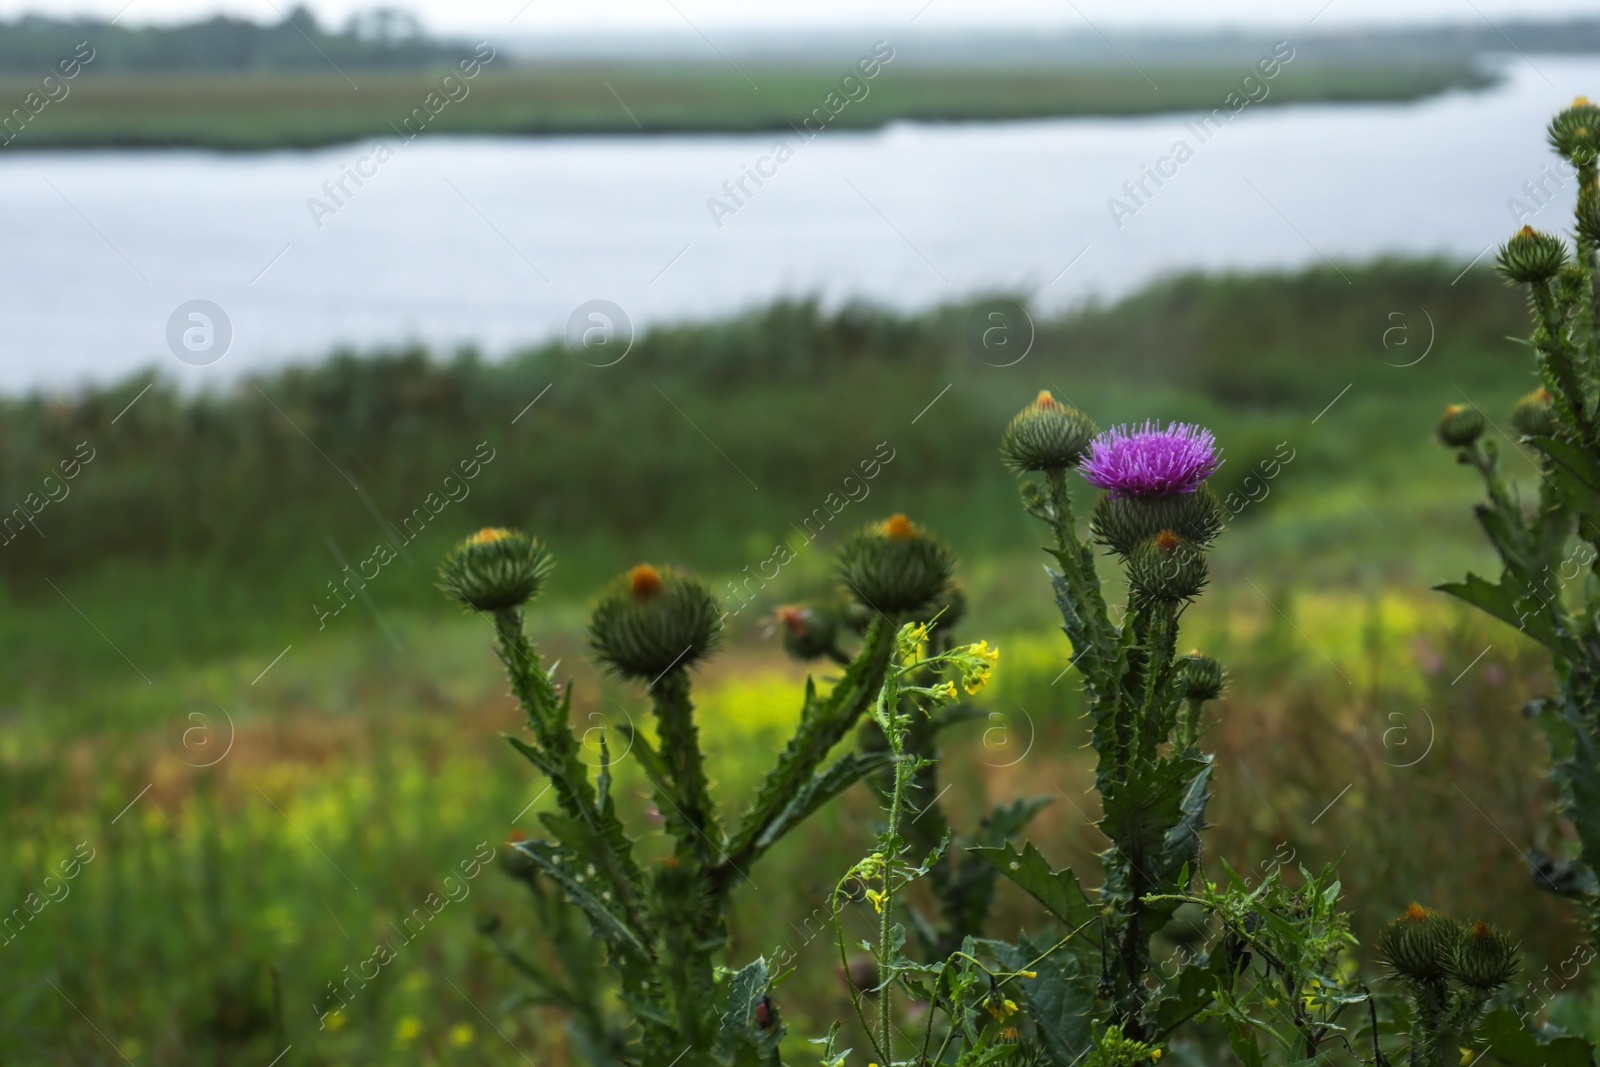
(0, 262), (1533, 595)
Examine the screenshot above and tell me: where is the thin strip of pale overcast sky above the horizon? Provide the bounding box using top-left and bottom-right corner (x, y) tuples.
(0, 0), (1595, 34)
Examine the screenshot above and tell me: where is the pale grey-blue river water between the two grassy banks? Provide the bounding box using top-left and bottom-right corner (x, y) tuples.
(0, 56), (1600, 392)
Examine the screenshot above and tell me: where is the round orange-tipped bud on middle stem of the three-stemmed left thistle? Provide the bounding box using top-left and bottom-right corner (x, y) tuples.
(589, 563), (722, 681)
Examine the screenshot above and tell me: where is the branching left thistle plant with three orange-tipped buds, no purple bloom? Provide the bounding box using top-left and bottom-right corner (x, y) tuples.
(440, 531), (934, 1067)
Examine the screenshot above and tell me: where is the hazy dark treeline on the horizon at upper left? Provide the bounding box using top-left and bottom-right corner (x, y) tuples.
(0, 6), (459, 75)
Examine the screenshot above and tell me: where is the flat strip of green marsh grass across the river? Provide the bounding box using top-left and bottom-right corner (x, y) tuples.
(0, 58), (1486, 150)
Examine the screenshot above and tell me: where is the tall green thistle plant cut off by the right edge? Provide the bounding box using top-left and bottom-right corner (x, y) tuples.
(1438, 99), (1600, 959)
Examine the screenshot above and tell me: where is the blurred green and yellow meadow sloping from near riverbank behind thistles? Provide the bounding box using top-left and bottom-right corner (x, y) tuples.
(0, 261), (1590, 1065)
